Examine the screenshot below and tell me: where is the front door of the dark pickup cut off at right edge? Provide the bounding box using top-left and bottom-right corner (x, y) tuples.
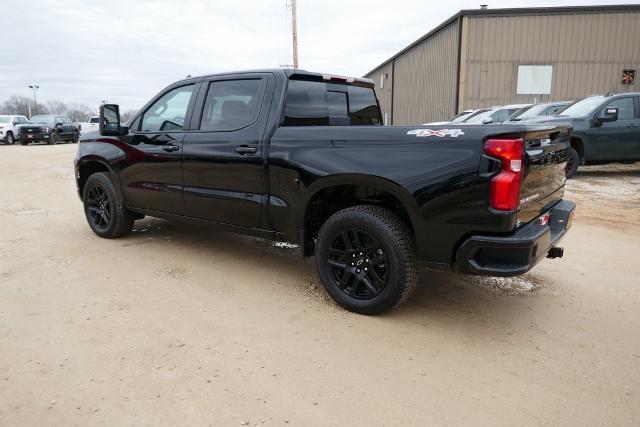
(589, 96), (640, 161)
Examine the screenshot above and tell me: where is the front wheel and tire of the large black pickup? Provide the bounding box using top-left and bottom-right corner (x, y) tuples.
(82, 172), (134, 239)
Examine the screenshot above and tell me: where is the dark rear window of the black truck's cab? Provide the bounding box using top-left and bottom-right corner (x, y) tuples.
(282, 80), (382, 126)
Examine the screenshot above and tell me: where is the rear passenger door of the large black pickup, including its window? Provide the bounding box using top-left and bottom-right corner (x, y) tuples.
(182, 73), (275, 227)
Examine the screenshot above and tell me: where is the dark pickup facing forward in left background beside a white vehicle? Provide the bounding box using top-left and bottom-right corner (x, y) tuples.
(18, 115), (80, 145)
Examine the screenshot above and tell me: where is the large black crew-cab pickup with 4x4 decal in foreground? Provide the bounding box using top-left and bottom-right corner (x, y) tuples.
(75, 69), (575, 314)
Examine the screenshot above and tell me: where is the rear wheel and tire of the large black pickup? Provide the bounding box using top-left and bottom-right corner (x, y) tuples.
(315, 205), (419, 314)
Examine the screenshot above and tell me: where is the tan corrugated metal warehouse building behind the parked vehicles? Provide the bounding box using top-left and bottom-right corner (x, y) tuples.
(365, 5), (640, 125)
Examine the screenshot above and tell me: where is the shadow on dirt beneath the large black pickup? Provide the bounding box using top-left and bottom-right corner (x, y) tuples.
(119, 218), (543, 323)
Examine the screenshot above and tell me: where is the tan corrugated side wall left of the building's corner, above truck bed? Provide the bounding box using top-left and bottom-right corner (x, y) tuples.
(393, 21), (458, 125)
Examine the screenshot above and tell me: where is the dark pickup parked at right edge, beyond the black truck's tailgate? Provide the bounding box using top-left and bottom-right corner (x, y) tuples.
(527, 93), (640, 177)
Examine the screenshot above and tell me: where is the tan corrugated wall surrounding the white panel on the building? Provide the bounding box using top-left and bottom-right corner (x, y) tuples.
(460, 12), (640, 109)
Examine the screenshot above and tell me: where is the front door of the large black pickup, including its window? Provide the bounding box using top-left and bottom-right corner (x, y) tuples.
(120, 83), (199, 215)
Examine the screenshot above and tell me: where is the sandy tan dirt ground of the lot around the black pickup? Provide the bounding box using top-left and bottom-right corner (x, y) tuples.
(0, 145), (640, 426)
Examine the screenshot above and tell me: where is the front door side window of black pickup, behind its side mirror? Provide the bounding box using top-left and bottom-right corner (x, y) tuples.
(141, 84), (193, 132)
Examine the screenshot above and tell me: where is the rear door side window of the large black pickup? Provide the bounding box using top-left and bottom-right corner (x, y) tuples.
(200, 79), (264, 131)
